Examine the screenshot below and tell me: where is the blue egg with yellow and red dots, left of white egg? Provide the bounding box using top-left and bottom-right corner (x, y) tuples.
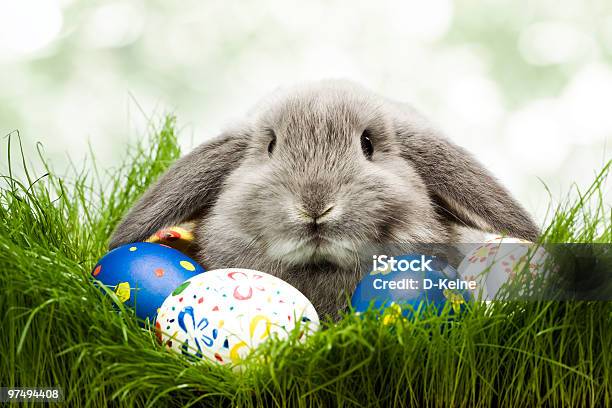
(91, 242), (205, 322)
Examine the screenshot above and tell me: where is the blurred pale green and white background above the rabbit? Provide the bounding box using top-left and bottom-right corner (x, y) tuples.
(0, 0), (612, 225)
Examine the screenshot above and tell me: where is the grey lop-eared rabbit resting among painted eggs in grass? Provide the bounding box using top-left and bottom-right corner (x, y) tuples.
(110, 81), (538, 316)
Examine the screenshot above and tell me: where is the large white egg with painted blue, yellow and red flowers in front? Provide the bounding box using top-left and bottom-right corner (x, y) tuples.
(155, 269), (319, 364)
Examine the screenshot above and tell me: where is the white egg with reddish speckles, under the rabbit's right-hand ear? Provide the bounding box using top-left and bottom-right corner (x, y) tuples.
(458, 237), (547, 300)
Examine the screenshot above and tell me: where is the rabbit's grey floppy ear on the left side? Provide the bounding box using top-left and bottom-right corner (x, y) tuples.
(109, 133), (248, 248)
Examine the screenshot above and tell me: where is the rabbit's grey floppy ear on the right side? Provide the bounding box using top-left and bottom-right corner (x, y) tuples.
(397, 107), (538, 241)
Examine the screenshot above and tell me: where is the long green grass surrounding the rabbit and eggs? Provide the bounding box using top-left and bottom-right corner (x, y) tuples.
(0, 118), (612, 407)
